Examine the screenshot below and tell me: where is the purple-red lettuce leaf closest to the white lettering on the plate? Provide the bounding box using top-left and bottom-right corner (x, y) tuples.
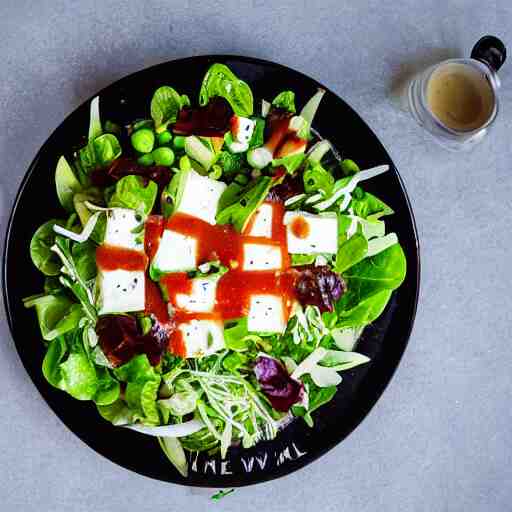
(254, 356), (304, 412)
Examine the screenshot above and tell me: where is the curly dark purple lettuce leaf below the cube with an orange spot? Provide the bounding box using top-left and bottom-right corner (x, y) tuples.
(295, 265), (347, 313)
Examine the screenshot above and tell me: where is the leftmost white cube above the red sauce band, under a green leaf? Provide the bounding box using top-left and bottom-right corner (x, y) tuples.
(104, 208), (144, 251)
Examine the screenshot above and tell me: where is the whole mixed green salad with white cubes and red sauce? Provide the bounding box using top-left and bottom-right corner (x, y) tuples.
(24, 64), (406, 475)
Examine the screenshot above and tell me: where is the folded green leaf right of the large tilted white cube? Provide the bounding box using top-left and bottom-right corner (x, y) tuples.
(216, 176), (272, 233)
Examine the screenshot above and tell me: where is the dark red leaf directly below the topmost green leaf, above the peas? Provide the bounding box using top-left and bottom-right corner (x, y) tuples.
(173, 96), (233, 137)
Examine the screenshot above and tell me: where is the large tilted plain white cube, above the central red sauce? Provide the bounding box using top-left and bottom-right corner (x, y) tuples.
(176, 170), (227, 226)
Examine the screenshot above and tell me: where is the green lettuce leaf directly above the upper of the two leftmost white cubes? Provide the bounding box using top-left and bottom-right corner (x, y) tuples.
(108, 175), (158, 216)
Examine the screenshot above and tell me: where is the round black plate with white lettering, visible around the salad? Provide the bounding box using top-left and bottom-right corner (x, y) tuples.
(3, 56), (419, 487)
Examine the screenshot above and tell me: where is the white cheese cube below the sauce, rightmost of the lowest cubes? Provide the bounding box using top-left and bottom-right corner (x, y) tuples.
(247, 295), (287, 333)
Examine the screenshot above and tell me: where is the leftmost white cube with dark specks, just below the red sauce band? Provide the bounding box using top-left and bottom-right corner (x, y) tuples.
(97, 270), (145, 315)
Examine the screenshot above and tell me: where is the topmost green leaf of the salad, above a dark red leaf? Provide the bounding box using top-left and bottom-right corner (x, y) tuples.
(199, 63), (253, 117)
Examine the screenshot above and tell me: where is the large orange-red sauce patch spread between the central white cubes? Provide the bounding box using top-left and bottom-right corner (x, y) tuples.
(146, 202), (295, 357)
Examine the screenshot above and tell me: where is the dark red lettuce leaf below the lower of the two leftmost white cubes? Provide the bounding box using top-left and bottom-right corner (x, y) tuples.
(96, 315), (168, 367)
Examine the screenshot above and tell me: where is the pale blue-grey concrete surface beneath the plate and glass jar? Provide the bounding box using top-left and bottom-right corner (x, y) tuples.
(0, 0), (512, 512)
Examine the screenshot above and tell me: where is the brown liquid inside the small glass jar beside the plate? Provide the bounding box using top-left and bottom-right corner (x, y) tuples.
(427, 63), (494, 132)
